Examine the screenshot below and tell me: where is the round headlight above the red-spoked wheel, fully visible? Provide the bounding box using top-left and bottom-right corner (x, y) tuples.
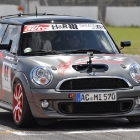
(30, 66), (53, 85)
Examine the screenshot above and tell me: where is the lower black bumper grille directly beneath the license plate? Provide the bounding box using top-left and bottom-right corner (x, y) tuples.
(58, 101), (133, 115)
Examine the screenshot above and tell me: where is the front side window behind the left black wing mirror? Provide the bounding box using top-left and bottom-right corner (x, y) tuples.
(2, 25), (21, 53)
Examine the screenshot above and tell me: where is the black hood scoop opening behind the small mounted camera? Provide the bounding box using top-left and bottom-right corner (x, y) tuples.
(72, 64), (108, 73)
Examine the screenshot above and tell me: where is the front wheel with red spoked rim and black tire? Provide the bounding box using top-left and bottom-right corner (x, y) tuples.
(13, 80), (35, 127)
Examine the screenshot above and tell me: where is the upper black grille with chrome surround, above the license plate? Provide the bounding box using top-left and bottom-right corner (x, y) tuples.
(59, 78), (129, 90)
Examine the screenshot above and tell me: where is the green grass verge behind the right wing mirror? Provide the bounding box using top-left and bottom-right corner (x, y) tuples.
(106, 26), (140, 54)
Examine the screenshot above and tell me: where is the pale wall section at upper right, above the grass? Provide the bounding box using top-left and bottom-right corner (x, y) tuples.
(105, 7), (140, 26)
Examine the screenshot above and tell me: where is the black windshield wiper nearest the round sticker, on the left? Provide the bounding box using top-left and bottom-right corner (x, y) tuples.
(22, 50), (63, 55)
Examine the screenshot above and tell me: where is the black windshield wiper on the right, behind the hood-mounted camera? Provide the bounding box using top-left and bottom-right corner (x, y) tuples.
(65, 49), (111, 54)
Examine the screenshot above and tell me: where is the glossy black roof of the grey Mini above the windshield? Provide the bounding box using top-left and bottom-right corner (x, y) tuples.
(0, 15), (100, 24)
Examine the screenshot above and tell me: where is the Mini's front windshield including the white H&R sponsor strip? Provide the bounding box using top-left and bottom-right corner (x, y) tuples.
(22, 24), (119, 53)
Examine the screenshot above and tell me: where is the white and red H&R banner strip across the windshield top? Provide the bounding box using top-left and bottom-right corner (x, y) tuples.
(23, 23), (105, 33)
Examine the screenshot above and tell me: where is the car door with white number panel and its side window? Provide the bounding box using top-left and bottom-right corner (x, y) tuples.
(0, 25), (21, 104)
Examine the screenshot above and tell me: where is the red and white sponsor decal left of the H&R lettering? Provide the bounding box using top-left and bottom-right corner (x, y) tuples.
(23, 24), (50, 33)
